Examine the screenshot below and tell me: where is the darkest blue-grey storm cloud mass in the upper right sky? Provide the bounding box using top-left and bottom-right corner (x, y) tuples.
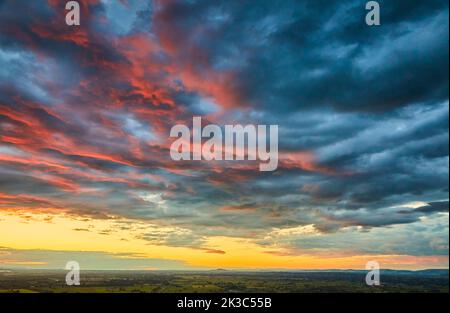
(157, 0), (448, 113)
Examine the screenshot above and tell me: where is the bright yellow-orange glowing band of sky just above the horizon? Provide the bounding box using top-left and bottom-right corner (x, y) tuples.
(0, 211), (448, 270)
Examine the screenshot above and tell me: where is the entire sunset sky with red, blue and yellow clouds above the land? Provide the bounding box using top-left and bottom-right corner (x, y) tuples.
(0, 0), (449, 270)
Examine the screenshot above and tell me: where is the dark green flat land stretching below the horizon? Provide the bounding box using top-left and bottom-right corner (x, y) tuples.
(0, 270), (449, 293)
